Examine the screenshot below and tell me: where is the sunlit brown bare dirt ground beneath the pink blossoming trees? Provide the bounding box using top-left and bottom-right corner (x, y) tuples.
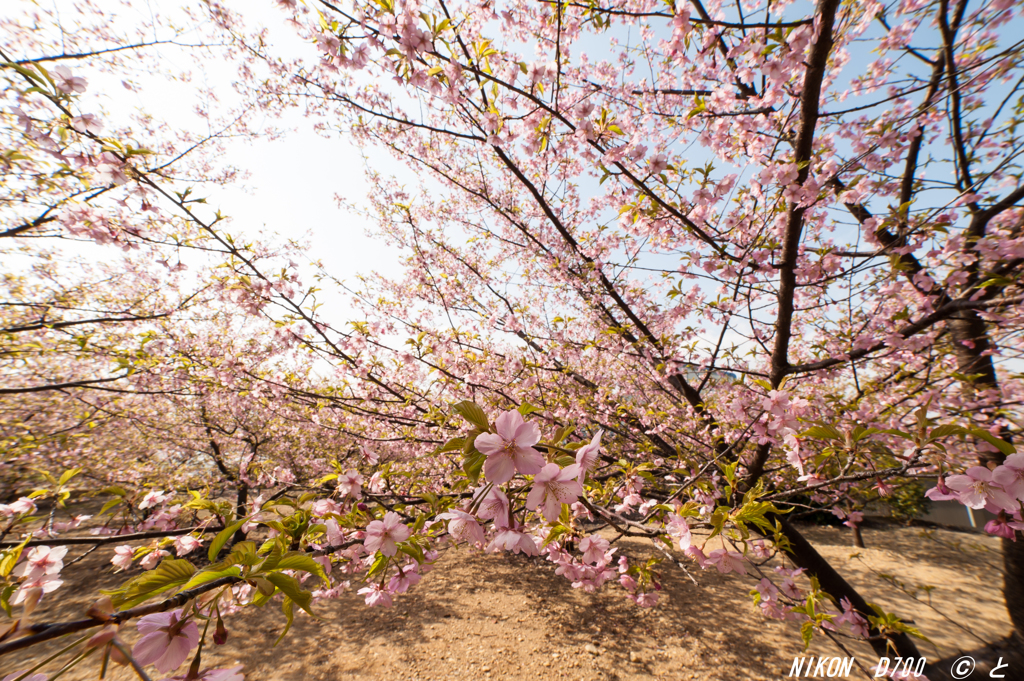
(6, 527), (1024, 681)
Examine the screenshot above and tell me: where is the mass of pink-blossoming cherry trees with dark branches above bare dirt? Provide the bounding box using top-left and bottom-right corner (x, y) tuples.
(0, 0), (1024, 681)
